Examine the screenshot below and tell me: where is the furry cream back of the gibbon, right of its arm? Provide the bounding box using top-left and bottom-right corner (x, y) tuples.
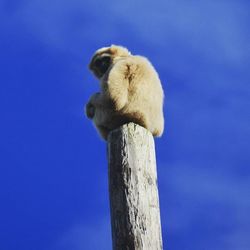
(118, 56), (164, 136)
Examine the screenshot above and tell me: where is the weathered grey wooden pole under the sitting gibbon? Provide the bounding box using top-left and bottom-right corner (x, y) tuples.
(108, 123), (163, 250)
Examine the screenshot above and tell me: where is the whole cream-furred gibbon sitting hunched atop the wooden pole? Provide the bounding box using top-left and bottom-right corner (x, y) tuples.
(85, 45), (164, 140)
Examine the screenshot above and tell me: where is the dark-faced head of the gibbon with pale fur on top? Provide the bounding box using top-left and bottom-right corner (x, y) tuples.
(89, 45), (131, 79)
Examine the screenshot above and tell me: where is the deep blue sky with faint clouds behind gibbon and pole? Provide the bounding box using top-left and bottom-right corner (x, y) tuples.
(0, 0), (250, 250)
